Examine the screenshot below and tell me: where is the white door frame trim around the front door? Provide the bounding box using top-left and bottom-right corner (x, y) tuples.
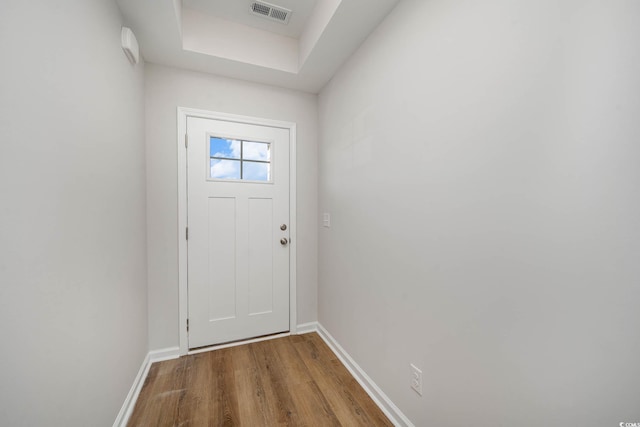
(177, 107), (298, 356)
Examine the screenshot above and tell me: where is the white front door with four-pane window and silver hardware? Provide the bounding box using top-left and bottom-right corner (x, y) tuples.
(187, 117), (290, 348)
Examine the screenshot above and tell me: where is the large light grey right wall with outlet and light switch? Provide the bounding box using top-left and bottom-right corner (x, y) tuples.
(318, 0), (640, 427)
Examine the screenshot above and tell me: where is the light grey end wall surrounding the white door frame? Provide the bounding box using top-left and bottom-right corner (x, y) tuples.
(145, 64), (318, 349)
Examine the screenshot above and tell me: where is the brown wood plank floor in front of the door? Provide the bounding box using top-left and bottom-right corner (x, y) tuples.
(129, 333), (392, 427)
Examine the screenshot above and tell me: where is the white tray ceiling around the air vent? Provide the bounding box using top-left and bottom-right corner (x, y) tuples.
(116, 0), (399, 93)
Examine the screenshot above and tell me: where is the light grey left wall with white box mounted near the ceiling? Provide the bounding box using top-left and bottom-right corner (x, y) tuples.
(0, 0), (147, 426)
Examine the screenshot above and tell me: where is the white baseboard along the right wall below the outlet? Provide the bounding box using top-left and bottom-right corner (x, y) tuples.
(317, 323), (415, 427)
